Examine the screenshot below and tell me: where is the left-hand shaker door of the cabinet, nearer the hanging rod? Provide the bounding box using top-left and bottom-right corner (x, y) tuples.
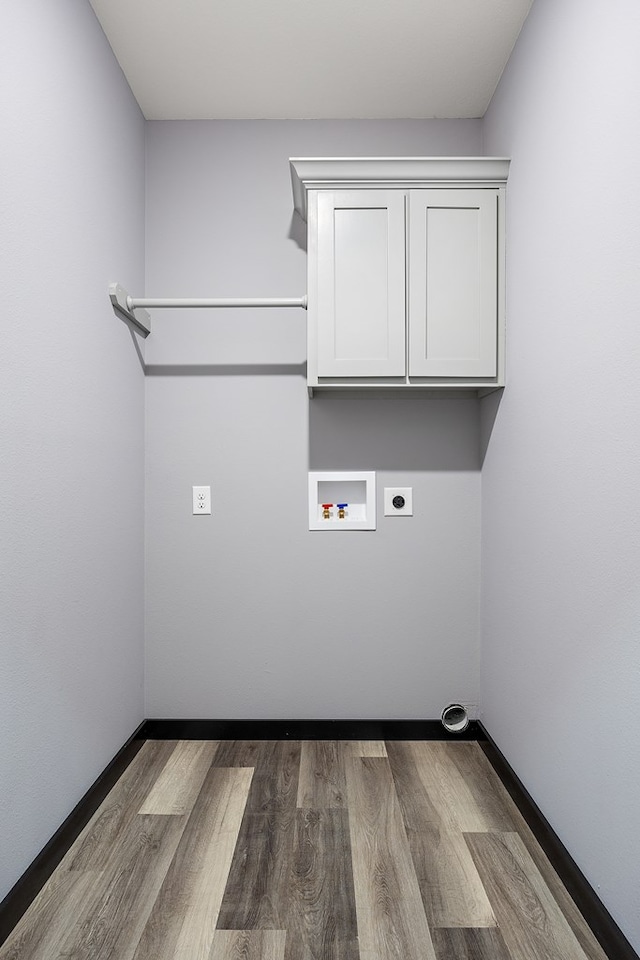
(317, 190), (406, 377)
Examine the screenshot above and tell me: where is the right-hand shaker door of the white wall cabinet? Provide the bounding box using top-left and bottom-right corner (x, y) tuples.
(409, 190), (498, 377)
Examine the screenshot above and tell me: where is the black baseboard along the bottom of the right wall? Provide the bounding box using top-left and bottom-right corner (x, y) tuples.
(478, 723), (640, 960)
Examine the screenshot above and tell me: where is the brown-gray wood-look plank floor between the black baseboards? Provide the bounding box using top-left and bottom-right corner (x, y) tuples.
(0, 740), (606, 960)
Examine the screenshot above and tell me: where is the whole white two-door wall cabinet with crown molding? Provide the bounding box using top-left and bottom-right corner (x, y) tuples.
(291, 158), (509, 392)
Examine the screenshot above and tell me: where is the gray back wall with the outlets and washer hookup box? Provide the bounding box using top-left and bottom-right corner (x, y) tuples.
(146, 121), (480, 717)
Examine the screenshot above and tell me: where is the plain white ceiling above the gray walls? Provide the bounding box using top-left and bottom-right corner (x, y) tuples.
(90, 0), (532, 120)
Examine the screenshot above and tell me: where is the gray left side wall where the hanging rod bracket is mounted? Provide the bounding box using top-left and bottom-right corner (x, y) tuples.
(0, 0), (144, 898)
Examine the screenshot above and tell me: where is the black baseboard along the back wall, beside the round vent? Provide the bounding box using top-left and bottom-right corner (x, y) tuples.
(141, 720), (484, 740)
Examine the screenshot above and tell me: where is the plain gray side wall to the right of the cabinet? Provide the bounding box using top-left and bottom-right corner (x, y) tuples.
(482, 0), (640, 949)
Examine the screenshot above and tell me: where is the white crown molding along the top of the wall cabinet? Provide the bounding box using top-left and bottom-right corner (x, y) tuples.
(289, 157), (511, 220)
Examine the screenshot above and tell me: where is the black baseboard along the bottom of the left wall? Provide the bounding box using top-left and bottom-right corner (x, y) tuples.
(0, 723), (144, 944)
